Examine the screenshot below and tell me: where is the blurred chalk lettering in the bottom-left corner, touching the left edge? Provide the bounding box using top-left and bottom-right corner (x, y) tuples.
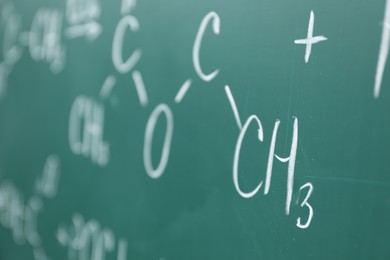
(0, 154), (61, 260)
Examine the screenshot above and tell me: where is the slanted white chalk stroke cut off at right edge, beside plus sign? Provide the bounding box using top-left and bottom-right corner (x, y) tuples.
(374, 0), (390, 98)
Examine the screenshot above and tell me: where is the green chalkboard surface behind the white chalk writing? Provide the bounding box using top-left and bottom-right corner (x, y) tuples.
(0, 0), (390, 260)
